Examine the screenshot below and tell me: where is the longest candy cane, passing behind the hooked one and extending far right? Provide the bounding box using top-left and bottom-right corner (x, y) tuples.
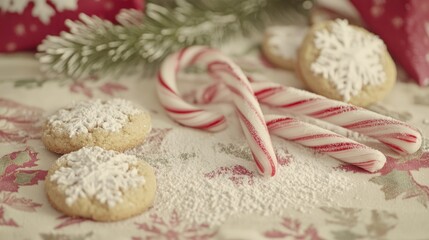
(191, 81), (422, 154)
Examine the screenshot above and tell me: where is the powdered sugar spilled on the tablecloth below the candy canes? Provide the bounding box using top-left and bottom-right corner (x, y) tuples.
(128, 115), (354, 225)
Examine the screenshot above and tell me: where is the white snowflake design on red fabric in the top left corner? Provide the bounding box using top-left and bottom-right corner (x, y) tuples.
(0, 0), (78, 24)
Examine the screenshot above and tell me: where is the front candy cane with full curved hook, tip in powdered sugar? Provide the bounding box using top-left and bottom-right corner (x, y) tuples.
(157, 46), (277, 176)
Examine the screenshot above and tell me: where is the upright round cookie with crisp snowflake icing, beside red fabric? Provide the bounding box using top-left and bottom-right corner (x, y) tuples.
(297, 19), (396, 107)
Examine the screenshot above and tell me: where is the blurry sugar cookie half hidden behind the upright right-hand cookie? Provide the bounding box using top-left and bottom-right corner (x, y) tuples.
(262, 25), (308, 70)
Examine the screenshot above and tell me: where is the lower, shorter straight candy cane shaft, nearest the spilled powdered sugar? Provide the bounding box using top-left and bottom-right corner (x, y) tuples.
(265, 115), (386, 172)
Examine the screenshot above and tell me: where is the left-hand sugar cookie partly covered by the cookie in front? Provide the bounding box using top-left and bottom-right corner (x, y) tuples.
(42, 99), (152, 154)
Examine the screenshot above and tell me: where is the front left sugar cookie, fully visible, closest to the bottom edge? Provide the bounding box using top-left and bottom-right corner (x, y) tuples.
(45, 147), (156, 221)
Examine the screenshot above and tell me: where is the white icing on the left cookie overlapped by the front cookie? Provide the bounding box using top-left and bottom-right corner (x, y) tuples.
(48, 98), (142, 137)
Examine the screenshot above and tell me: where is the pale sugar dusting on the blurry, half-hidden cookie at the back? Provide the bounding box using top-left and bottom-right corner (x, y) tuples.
(267, 26), (308, 60)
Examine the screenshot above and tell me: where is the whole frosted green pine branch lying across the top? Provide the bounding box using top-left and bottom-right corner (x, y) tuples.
(38, 0), (311, 77)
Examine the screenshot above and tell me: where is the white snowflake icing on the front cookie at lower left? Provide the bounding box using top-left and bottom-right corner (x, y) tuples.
(50, 147), (145, 208)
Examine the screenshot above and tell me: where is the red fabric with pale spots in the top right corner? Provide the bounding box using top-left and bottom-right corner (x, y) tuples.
(351, 0), (429, 86)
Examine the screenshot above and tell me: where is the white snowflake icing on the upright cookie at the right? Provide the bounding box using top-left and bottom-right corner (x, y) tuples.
(311, 19), (386, 101)
